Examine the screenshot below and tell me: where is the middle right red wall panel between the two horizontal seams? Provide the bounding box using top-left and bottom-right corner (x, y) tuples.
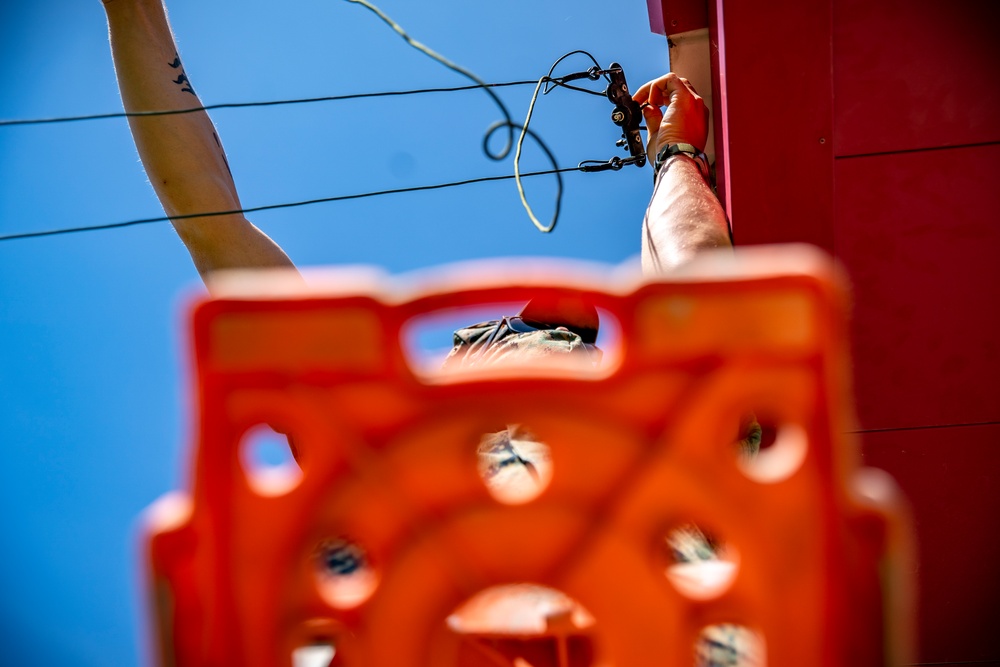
(836, 144), (1000, 428)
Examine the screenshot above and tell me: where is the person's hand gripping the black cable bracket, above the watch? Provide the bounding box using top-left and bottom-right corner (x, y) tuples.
(632, 72), (708, 164)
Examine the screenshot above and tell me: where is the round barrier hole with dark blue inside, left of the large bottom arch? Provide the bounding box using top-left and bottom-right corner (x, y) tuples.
(314, 537), (378, 609)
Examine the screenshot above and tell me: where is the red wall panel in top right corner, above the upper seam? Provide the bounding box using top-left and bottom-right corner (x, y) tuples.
(833, 0), (1000, 155)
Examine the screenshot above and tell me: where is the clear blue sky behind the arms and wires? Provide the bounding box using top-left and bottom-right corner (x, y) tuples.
(0, 0), (667, 667)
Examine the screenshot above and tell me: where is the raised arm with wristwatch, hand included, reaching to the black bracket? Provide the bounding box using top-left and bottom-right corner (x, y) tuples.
(634, 73), (732, 273)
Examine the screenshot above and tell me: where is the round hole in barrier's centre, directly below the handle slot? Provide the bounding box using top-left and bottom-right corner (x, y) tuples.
(477, 424), (552, 505)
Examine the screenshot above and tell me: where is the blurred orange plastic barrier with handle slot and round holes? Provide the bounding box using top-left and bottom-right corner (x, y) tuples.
(146, 247), (911, 667)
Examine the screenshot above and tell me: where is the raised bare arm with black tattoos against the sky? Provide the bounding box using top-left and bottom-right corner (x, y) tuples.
(103, 0), (292, 278)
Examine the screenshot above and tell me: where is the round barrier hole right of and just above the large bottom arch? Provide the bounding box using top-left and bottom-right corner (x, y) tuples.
(663, 525), (739, 600)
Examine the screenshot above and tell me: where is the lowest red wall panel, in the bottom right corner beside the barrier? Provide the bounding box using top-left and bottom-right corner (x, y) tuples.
(863, 424), (1000, 665)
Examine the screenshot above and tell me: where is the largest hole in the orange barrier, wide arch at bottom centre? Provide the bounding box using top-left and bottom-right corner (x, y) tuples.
(447, 584), (596, 667)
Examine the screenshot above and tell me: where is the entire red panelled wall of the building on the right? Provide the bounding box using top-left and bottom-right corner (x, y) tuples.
(661, 0), (1000, 664)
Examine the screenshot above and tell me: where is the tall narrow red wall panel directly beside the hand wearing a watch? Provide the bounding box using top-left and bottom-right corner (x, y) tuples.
(715, 0), (833, 250)
